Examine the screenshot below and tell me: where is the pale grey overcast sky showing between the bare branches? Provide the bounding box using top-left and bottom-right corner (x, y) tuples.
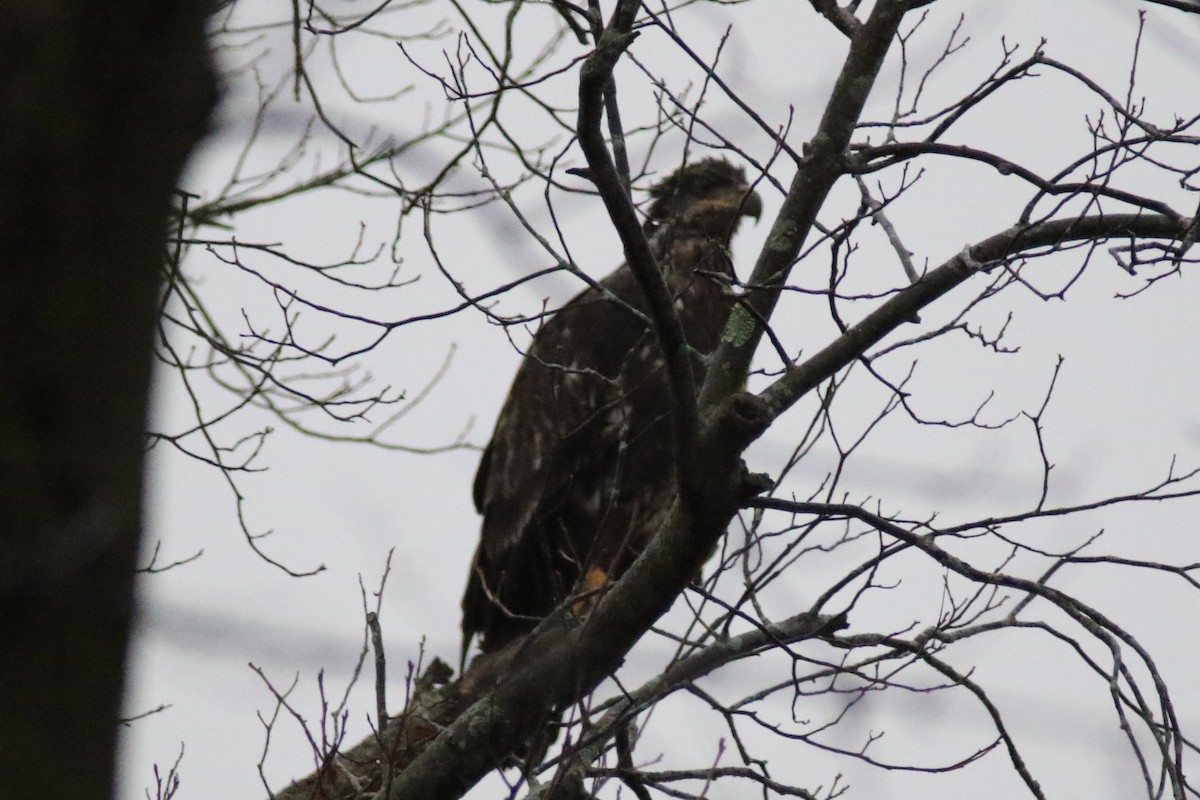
(120, 0), (1200, 800)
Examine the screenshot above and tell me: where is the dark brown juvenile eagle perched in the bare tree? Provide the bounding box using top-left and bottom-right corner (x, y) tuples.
(462, 158), (762, 655)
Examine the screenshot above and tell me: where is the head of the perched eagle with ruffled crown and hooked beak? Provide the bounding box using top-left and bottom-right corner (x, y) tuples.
(644, 158), (762, 239)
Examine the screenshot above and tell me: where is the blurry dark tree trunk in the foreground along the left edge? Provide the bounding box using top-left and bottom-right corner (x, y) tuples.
(0, 0), (216, 800)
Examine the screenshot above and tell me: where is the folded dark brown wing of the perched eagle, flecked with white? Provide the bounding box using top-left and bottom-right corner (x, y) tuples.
(463, 278), (650, 649)
